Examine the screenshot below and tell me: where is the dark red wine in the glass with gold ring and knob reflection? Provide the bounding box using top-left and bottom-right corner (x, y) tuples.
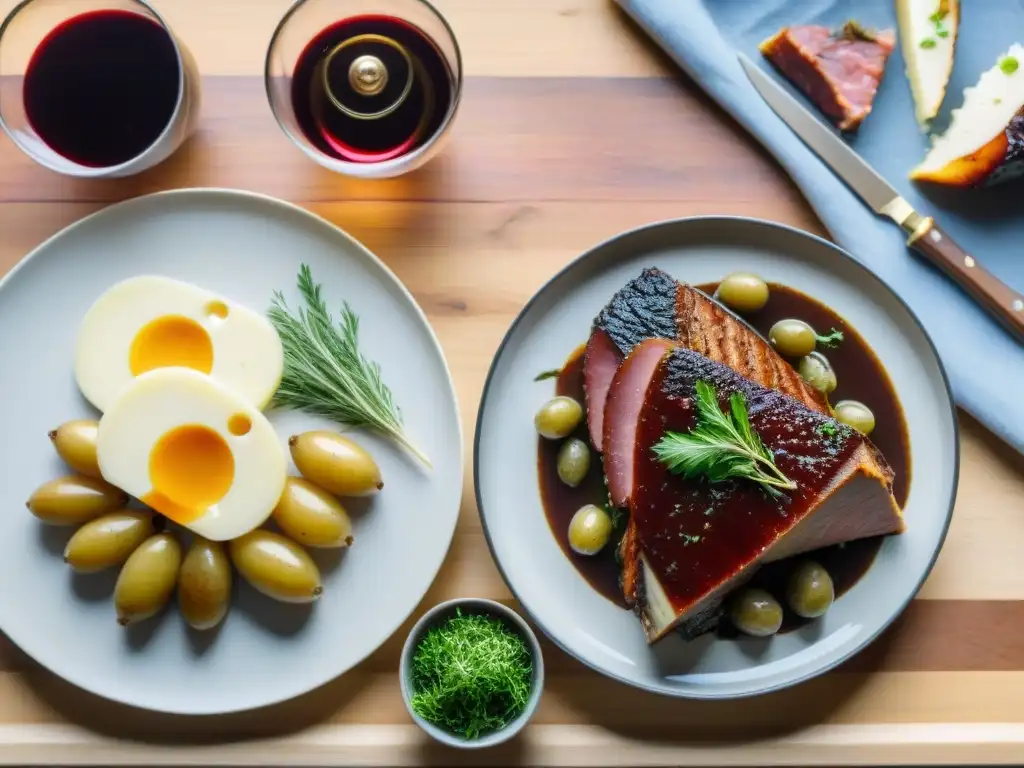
(292, 15), (455, 163)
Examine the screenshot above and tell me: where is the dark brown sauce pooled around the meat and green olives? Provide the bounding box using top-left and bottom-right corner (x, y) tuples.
(538, 284), (911, 636)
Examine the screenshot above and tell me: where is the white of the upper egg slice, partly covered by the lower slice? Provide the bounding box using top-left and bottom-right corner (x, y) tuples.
(75, 275), (285, 411)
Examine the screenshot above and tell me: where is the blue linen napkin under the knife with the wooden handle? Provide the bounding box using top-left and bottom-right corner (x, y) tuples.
(616, 0), (1024, 452)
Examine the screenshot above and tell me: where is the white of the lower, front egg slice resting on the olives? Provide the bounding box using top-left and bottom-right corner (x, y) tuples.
(96, 368), (287, 541)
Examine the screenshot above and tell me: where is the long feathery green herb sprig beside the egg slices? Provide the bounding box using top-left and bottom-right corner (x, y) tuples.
(267, 264), (430, 467)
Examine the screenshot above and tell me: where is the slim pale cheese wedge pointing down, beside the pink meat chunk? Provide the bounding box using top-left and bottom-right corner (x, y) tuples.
(896, 0), (961, 125)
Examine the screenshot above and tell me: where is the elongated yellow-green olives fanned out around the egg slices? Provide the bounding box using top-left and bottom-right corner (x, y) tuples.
(26, 428), (384, 630)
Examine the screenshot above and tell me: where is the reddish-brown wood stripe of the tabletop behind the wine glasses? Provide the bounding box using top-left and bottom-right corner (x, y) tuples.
(0, 77), (799, 203)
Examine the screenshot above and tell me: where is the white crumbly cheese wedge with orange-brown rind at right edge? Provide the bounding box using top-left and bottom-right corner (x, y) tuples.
(910, 44), (1024, 186)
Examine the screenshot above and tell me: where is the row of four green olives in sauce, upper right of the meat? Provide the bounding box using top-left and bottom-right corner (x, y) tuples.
(715, 272), (874, 435)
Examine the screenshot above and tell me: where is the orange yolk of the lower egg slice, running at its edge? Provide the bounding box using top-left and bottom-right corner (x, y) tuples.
(142, 424), (234, 525)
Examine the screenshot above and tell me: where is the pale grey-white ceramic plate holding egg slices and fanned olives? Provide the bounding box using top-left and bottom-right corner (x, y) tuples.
(0, 190), (463, 714)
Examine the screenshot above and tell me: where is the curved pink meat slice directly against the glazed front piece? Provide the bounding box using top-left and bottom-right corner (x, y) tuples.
(604, 339), (674, 507)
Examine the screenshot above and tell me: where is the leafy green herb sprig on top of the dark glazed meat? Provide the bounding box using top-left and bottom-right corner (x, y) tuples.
(652, 381), (797, 496)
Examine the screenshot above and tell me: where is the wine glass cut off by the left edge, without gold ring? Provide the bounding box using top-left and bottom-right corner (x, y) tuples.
(0, 0), (200, 177)
